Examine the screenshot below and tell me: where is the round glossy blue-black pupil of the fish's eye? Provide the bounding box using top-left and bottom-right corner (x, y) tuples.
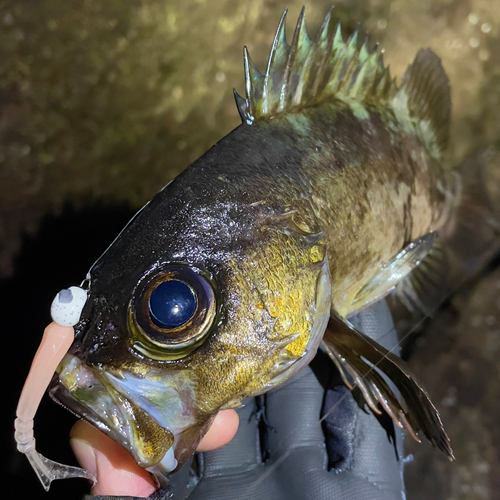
(149, 280), (196, 329)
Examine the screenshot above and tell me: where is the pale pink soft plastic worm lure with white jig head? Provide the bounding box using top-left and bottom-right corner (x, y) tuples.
(14, 287), (97, 491)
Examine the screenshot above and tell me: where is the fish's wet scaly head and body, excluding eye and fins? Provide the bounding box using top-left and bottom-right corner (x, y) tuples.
(47, 11), (468, 471)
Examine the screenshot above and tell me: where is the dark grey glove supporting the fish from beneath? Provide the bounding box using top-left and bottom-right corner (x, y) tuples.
(166, 301), (404, 500)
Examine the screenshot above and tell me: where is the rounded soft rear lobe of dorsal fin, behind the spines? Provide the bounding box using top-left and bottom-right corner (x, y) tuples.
(391, 49), (451, 158)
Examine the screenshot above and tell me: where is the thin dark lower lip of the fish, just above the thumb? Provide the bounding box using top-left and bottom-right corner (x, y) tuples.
(48, 373), (131, 450)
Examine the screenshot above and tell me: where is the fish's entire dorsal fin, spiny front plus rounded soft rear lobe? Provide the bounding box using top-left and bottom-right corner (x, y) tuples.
(235, 8), (451, 158)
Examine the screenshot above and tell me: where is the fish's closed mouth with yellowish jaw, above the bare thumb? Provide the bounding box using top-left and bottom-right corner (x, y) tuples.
(49, 354), (177, 472)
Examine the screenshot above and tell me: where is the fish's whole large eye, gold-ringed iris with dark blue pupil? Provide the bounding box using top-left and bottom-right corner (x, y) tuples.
(129, 265), (217, 359)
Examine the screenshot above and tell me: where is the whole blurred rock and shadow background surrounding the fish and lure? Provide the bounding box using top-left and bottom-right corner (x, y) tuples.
(0, 0), (500, 500)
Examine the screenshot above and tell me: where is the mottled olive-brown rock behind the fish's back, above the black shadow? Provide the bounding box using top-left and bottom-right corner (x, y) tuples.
(0, 0), (500, 275)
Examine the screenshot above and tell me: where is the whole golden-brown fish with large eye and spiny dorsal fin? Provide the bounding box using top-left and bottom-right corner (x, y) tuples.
(49, 9), (499, 476)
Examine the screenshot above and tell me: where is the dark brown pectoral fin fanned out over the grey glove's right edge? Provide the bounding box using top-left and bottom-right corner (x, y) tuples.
(323, 312), (455, 460)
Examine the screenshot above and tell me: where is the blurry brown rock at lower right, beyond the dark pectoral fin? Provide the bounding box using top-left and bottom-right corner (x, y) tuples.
(405, 268), (500, 500)
